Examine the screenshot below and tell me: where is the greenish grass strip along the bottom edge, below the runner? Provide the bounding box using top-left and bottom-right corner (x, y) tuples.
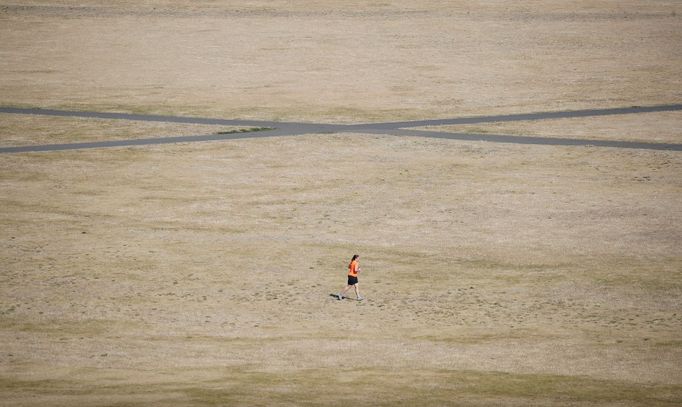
(0, 367), (682, 406)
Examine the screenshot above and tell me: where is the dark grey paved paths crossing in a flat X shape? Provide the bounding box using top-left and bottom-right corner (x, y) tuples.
(0, 104), (682, 153)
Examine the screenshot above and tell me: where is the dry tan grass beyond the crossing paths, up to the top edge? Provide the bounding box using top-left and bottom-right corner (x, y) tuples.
(0, 0), (682, 122)
